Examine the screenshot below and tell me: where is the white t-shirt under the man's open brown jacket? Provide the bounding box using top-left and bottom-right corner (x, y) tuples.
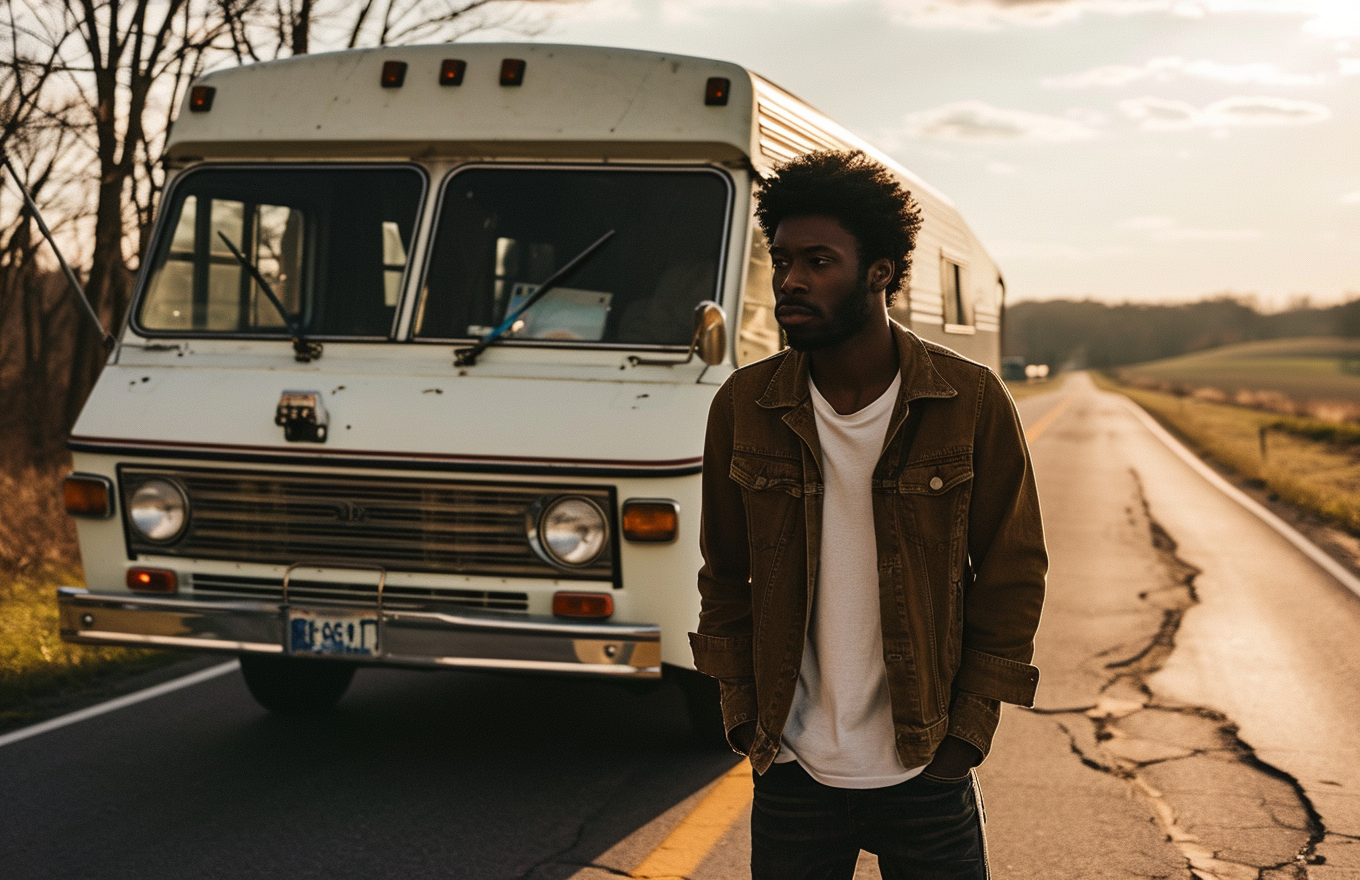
(775, 373), (922, 789)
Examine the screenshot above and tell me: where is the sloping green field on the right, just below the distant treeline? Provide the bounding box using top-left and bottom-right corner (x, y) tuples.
(1117, 337), (1360, 405)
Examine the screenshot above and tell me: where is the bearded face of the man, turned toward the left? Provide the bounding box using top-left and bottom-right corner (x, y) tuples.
(770, 215), (883, 351)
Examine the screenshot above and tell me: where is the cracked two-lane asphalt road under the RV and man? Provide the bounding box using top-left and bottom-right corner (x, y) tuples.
(0, 375), (1360, 880)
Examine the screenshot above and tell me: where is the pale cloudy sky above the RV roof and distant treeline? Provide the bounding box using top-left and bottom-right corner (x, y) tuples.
(470, 0), (1360, 307)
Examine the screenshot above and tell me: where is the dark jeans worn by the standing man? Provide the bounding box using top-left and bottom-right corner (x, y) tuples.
(751, 762), (991, 880)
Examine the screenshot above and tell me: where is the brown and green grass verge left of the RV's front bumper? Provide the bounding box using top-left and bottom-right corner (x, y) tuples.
(0, 467), (166, 726)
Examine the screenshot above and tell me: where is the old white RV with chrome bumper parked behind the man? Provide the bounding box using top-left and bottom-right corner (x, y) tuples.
(60, 44), (1004, 724)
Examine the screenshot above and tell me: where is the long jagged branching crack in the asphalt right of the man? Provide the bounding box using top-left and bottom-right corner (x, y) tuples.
(1035, 469), (1316, 880)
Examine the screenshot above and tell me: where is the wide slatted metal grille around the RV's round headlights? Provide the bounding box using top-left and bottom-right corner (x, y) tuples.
(120, 468), (616, 581)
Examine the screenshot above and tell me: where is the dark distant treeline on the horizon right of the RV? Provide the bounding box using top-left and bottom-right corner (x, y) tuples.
(1002, 297), (1360, 369)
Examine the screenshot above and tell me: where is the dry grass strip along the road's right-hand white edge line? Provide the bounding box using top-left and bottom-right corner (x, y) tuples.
(1100, 379), (1360, 535)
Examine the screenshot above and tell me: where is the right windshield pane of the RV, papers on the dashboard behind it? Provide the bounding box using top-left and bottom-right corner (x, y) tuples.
(415, 167), (729, 345)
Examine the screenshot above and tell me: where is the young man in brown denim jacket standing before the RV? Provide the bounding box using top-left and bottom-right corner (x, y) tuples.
(690, 152), (1047, 880)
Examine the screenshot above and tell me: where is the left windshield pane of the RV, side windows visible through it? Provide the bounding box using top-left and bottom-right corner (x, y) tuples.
(137, 167), (424, 339)
